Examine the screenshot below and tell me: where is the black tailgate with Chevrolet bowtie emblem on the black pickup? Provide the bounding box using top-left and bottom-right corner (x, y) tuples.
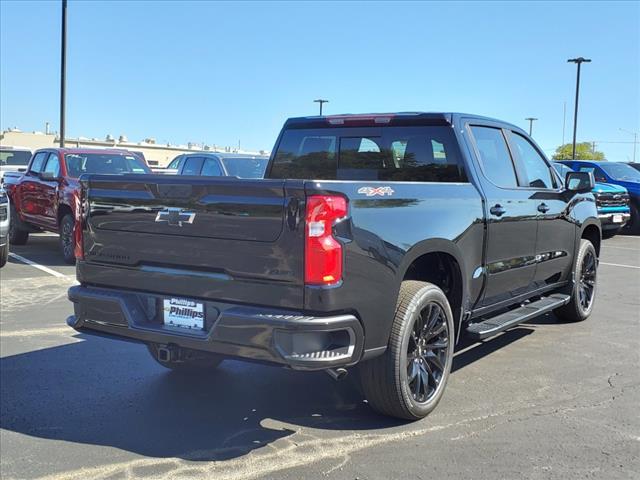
(78, 175), (304, 308)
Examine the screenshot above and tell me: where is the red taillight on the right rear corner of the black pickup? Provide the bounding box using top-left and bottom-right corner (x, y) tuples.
(304, 195), (347, 285)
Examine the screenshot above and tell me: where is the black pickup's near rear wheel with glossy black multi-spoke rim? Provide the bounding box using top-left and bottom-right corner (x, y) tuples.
(359, 280), (455, 420)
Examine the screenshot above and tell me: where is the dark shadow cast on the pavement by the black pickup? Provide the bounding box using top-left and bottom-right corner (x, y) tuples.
(0, 328), (533, 461)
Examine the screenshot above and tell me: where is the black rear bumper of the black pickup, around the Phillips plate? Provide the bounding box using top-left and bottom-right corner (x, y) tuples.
(67, 286), (364, 370)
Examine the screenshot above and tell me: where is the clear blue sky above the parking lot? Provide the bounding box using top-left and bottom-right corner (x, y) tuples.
(0, 0), (640, 161)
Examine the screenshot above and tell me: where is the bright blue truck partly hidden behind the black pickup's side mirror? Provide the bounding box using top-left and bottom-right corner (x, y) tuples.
(553, 162), (631, 237)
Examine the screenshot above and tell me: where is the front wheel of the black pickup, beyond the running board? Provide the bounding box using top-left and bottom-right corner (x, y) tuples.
(555, 238), (598, 322)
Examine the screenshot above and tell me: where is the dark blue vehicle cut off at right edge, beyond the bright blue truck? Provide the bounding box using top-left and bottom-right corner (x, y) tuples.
(562, 160), (640, 235)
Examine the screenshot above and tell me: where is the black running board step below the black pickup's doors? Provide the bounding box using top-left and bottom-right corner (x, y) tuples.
(467, 293), (571, 340)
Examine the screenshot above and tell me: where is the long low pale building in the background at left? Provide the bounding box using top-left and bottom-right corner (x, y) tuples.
(0, 128), (268, 167)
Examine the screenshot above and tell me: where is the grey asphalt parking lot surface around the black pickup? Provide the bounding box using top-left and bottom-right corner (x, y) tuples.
(0, 234), (640, 480)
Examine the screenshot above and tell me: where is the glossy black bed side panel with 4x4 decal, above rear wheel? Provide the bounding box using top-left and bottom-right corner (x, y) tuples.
(305, 180), (484, 349)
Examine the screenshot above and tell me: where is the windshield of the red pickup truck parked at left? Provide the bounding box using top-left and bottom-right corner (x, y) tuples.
(64, 153), (149, 177)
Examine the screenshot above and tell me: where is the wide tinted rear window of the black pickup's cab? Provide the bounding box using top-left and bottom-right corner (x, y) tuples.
(269, 126), (467, 182)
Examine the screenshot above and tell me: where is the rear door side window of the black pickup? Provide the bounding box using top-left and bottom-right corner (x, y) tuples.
(471, 126), (518, 188)
